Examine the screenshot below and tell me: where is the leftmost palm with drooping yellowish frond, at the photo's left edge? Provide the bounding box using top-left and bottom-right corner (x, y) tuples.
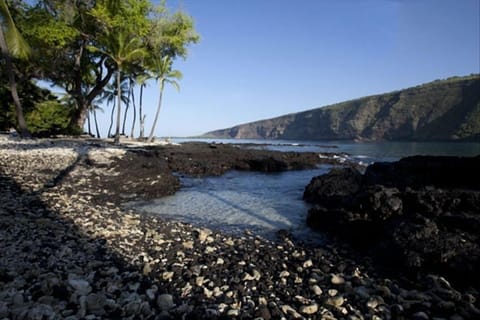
(0, 0), (30, 137)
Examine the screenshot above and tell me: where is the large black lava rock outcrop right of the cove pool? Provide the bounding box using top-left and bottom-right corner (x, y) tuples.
(304, 156), (480, 285)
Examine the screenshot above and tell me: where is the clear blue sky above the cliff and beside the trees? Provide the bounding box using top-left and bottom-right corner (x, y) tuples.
(93, 0), (480, 136)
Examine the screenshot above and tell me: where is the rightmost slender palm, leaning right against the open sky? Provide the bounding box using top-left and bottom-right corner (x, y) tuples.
(147, 56), (182, 142)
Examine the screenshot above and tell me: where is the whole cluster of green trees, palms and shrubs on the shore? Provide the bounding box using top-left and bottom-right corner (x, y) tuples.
(0, 0), (199, 142)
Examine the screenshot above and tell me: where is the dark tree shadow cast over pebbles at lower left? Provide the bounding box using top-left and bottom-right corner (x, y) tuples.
(0, 145), (165, 319)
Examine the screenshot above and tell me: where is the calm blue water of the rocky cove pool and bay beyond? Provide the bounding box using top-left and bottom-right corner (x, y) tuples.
(133, 139), (480, 242)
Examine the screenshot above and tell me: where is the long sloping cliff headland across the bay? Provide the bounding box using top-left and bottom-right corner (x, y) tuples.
(203, 74), (480, 141)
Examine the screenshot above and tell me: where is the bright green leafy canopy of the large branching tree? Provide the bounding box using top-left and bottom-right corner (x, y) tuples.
(1, 0), (199, 137)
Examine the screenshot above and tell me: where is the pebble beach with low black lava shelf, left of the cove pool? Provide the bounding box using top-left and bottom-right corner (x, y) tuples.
(0, 138), (480, 320)
